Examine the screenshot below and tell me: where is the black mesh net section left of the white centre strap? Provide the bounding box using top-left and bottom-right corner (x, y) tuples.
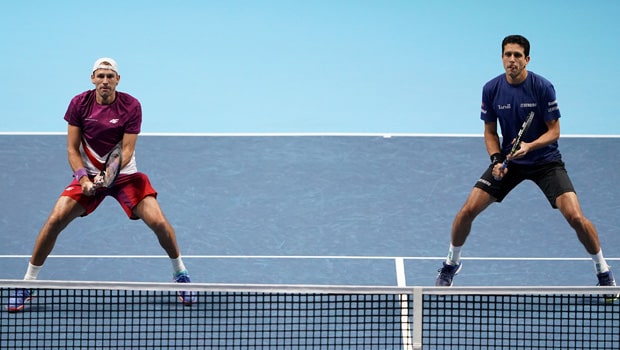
(0, 281), (411, 349)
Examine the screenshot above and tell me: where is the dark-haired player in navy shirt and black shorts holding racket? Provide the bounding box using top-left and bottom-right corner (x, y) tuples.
(435, 35), (617, 299)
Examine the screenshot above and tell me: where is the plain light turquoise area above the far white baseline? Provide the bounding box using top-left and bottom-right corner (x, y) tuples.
(0, 0), (620, 135)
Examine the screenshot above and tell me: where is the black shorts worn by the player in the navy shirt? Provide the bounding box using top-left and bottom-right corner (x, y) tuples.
(474, 161), (575, 208)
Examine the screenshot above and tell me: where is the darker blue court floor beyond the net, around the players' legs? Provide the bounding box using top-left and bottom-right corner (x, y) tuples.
(0, 135), (620, 286)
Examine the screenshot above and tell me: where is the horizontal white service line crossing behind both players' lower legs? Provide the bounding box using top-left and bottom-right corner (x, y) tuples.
(0, 254), (620, 261)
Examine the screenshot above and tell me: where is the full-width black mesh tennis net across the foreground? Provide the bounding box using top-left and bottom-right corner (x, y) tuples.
(0, 280), (620, 350)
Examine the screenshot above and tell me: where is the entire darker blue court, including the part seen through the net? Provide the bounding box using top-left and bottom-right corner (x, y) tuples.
(0, 134), (620, 350)
